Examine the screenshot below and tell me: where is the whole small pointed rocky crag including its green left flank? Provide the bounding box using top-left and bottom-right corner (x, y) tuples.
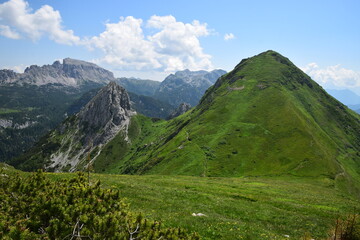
(13, 82), (135, 171)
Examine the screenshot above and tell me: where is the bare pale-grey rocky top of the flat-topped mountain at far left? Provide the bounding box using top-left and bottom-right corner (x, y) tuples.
(0, 58), (115, 86)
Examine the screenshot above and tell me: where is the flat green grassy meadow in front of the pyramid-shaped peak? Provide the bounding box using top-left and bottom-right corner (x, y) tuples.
(48, 173), (360, 239)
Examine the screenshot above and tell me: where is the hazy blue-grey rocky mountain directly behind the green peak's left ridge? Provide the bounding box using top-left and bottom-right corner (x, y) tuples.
(154, 70), (226, 107)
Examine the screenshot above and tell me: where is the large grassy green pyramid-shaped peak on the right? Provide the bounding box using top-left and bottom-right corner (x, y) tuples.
(99, 51), (360, 193)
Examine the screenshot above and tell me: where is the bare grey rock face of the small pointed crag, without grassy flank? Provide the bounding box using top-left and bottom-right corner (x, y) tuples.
(47, 82), (136, 171)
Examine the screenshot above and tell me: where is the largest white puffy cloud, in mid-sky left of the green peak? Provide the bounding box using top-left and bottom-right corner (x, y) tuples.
(89, 16), (212, 71)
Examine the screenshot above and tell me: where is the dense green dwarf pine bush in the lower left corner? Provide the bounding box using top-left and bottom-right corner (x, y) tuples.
(0, 171), (199, 239)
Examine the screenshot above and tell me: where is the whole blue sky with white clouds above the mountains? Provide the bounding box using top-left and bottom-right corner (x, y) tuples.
(0, 0), (360, 95)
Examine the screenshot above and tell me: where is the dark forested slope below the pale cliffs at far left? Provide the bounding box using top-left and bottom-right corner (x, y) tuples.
(0, 84), (105, 162)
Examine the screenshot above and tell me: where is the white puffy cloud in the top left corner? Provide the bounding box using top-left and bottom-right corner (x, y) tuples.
(0, 0), (80, 45)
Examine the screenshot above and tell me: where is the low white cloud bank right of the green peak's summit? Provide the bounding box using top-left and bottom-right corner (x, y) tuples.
(302, 63), (360, 88)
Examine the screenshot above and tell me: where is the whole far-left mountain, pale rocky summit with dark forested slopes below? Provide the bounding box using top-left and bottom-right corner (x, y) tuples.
(0, 58), (115, 162)
